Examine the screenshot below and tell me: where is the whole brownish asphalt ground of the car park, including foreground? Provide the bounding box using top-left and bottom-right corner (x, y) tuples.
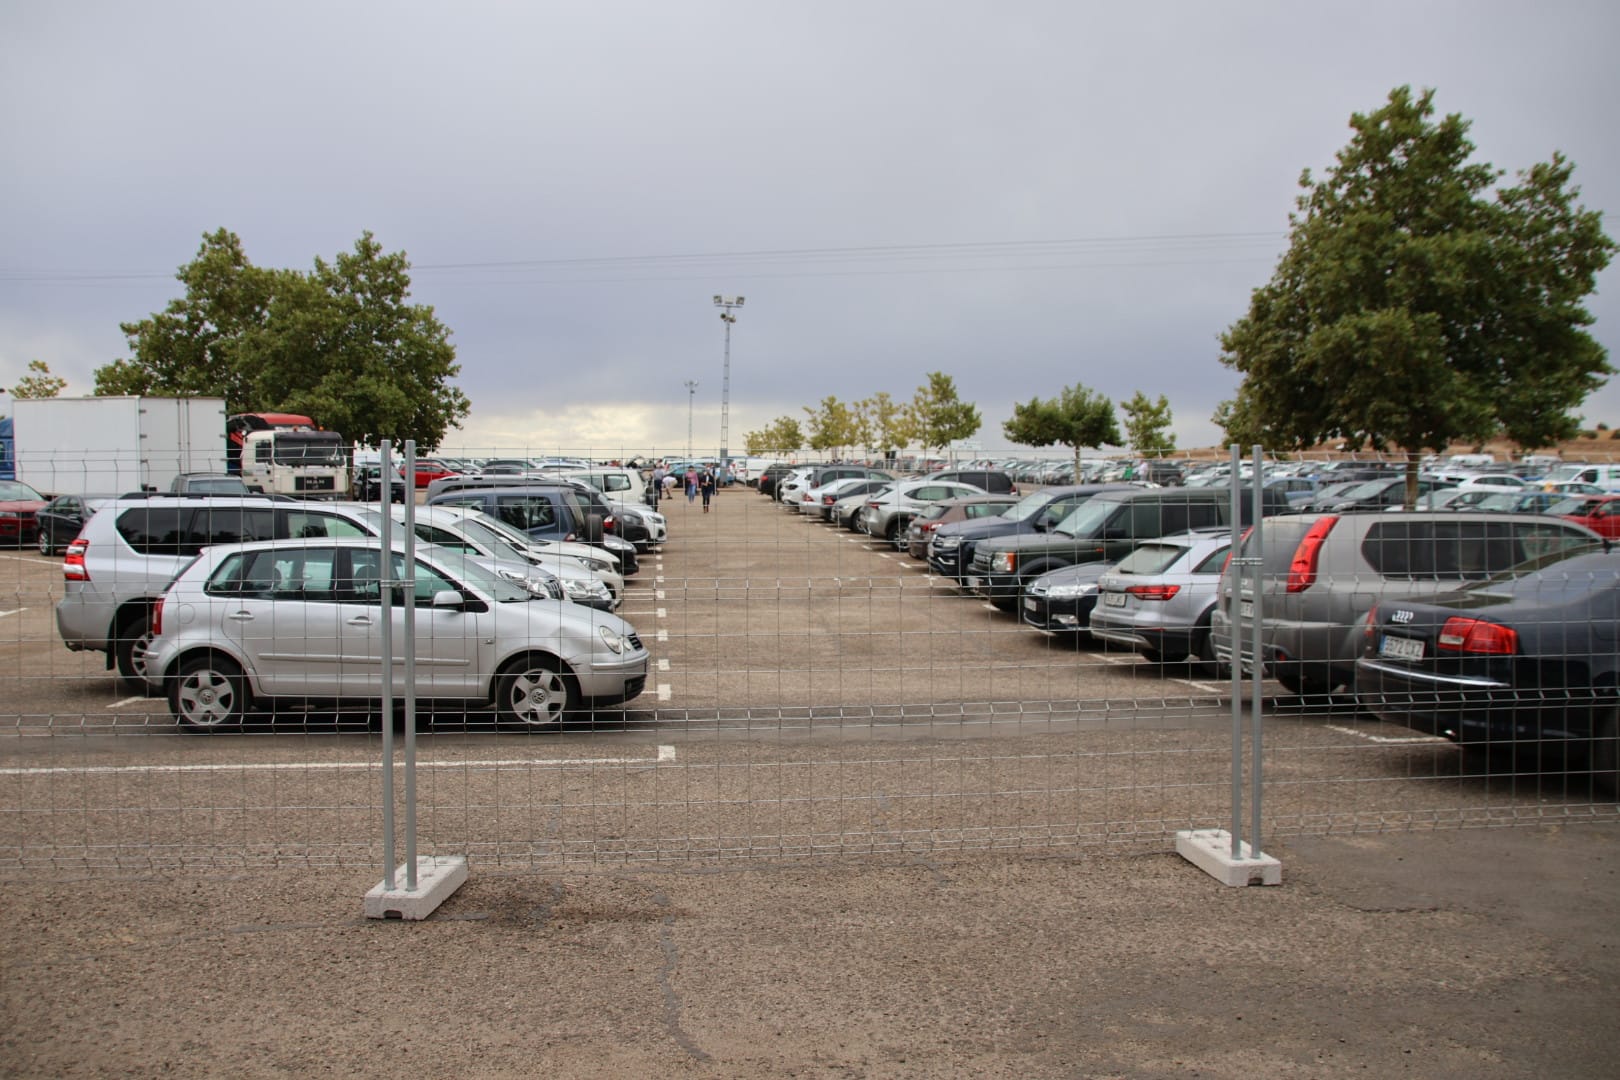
(0, 491), (1620, 1077)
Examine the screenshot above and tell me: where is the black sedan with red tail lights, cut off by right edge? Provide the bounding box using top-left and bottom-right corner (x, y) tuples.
(1356, 552), (1620, 792)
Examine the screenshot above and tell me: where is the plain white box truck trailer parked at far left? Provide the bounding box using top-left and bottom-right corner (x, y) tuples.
(11, 397), (225, 495)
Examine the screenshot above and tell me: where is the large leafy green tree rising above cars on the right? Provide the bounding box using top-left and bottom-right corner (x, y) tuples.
(1218, 87), (1615, 505)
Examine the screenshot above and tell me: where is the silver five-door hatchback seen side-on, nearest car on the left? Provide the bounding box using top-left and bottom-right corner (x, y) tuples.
(146, 538), (648, 732)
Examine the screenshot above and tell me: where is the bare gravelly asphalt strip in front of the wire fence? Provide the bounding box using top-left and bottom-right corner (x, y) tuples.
(0, 824), (1620, 1080)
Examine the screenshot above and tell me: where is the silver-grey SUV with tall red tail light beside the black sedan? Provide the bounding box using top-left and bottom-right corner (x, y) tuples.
(1210, 512), (1604, 695)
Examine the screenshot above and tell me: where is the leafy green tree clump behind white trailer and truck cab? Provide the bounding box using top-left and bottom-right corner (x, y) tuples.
(96, 228), (470, 450)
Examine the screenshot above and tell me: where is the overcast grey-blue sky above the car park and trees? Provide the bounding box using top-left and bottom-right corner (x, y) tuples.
(0, 0), (1620, 455)
